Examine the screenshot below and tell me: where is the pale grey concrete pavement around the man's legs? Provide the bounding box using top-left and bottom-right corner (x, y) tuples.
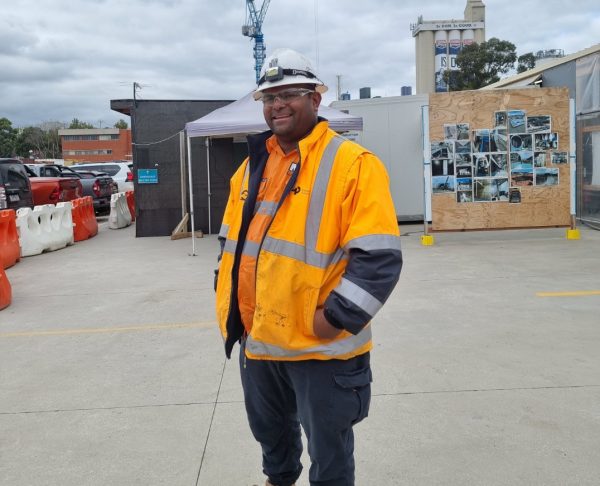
(0, 219), (600, 486)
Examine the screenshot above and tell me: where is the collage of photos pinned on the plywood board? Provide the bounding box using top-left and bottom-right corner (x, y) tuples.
(431, 110), (568, 203)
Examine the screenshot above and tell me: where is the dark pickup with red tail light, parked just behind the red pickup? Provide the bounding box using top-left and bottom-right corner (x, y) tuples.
(27, 164), (118, 213)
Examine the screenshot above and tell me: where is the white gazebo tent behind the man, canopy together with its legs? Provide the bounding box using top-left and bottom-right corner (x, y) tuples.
(185, 92), (363, 255)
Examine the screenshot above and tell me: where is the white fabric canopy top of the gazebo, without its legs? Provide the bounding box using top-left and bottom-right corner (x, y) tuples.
(185, 92), (362, 137)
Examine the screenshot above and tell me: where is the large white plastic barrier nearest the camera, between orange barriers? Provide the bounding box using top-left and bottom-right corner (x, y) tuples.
(17, 202), (74, 257)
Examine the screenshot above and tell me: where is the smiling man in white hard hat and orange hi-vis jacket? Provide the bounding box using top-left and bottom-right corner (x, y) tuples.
(217, 49), (402, 486)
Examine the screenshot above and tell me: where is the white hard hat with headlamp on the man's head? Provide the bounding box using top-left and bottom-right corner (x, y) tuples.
(254, 48), (327, 100)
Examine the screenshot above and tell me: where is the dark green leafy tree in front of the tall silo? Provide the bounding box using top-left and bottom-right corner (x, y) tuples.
(444, 37), (517, 91)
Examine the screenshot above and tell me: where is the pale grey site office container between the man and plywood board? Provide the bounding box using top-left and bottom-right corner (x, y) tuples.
(331, 95), (429, 222)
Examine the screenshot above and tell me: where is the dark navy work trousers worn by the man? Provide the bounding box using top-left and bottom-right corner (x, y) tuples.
(240, 343), (372, 486)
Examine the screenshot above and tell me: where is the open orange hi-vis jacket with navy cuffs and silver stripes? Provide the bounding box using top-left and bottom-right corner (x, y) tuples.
(216, 119), (402, 361)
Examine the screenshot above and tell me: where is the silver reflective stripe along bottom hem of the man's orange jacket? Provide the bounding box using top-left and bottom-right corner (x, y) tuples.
(246, 326), (371, 358)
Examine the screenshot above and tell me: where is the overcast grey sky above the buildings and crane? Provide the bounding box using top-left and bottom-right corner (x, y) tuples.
(0, 0), (600, 127)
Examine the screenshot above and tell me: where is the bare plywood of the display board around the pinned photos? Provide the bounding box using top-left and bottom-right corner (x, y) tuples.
(429, 88), (570, 231)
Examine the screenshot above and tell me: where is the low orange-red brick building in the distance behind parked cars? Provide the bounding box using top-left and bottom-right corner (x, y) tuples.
(58, 128), (132, 162)
